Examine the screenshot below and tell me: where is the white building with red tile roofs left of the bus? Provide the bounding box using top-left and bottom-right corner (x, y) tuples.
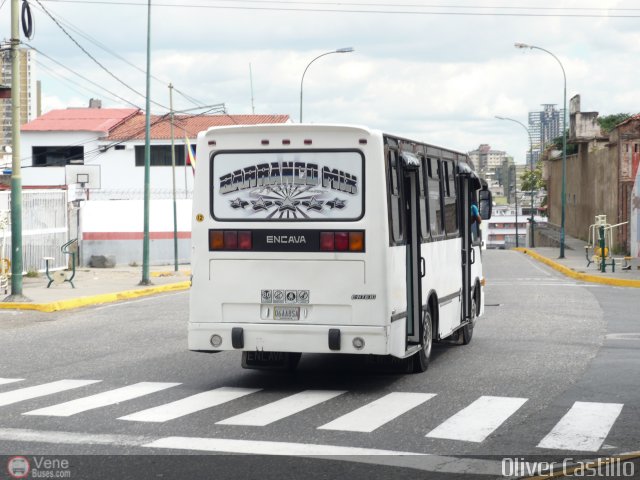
(21, 108), (290, 265)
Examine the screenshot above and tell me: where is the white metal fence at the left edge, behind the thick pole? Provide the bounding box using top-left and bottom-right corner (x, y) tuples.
(0, 190), (69, 273)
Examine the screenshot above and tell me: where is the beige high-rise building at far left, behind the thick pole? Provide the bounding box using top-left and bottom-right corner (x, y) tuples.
(0, 48), (39, 147)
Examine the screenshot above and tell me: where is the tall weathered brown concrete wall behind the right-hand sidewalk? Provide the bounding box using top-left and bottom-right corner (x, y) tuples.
(547, 143), (620, 248)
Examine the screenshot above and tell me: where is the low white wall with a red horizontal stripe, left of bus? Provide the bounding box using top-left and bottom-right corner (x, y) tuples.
(80, 199), (191, 266)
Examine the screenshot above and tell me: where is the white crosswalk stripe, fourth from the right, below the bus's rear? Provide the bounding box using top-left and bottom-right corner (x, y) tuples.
(217, 390), (345, 427)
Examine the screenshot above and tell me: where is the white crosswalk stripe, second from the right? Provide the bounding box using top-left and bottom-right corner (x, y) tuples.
(426, 396), (527, 442)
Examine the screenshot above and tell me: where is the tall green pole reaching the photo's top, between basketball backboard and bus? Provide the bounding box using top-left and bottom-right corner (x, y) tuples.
(140, 0), (151, 285)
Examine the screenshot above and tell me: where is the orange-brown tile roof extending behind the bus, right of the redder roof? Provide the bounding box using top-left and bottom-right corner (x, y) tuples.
(107, 113), (289, 140)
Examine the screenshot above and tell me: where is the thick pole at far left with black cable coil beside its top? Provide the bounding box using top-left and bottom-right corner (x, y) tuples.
(5, 0), (30, 302)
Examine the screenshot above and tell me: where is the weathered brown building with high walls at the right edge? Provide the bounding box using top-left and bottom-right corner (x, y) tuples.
(543, 95), (640, 257)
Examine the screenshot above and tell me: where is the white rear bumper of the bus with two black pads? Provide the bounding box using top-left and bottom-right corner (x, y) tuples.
(188, 323), (389, 355)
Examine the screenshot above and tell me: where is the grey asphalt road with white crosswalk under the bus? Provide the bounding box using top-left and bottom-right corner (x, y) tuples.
(0, 251), (640, 479)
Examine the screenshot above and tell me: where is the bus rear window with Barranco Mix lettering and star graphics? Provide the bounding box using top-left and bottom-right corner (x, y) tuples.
(211, 150), (364, 222)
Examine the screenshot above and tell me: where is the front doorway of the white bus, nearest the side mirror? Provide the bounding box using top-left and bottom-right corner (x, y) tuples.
(458, 172), (475, 322)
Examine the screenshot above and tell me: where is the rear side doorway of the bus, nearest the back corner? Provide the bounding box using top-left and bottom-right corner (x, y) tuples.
(400, 152), (425, 350)
